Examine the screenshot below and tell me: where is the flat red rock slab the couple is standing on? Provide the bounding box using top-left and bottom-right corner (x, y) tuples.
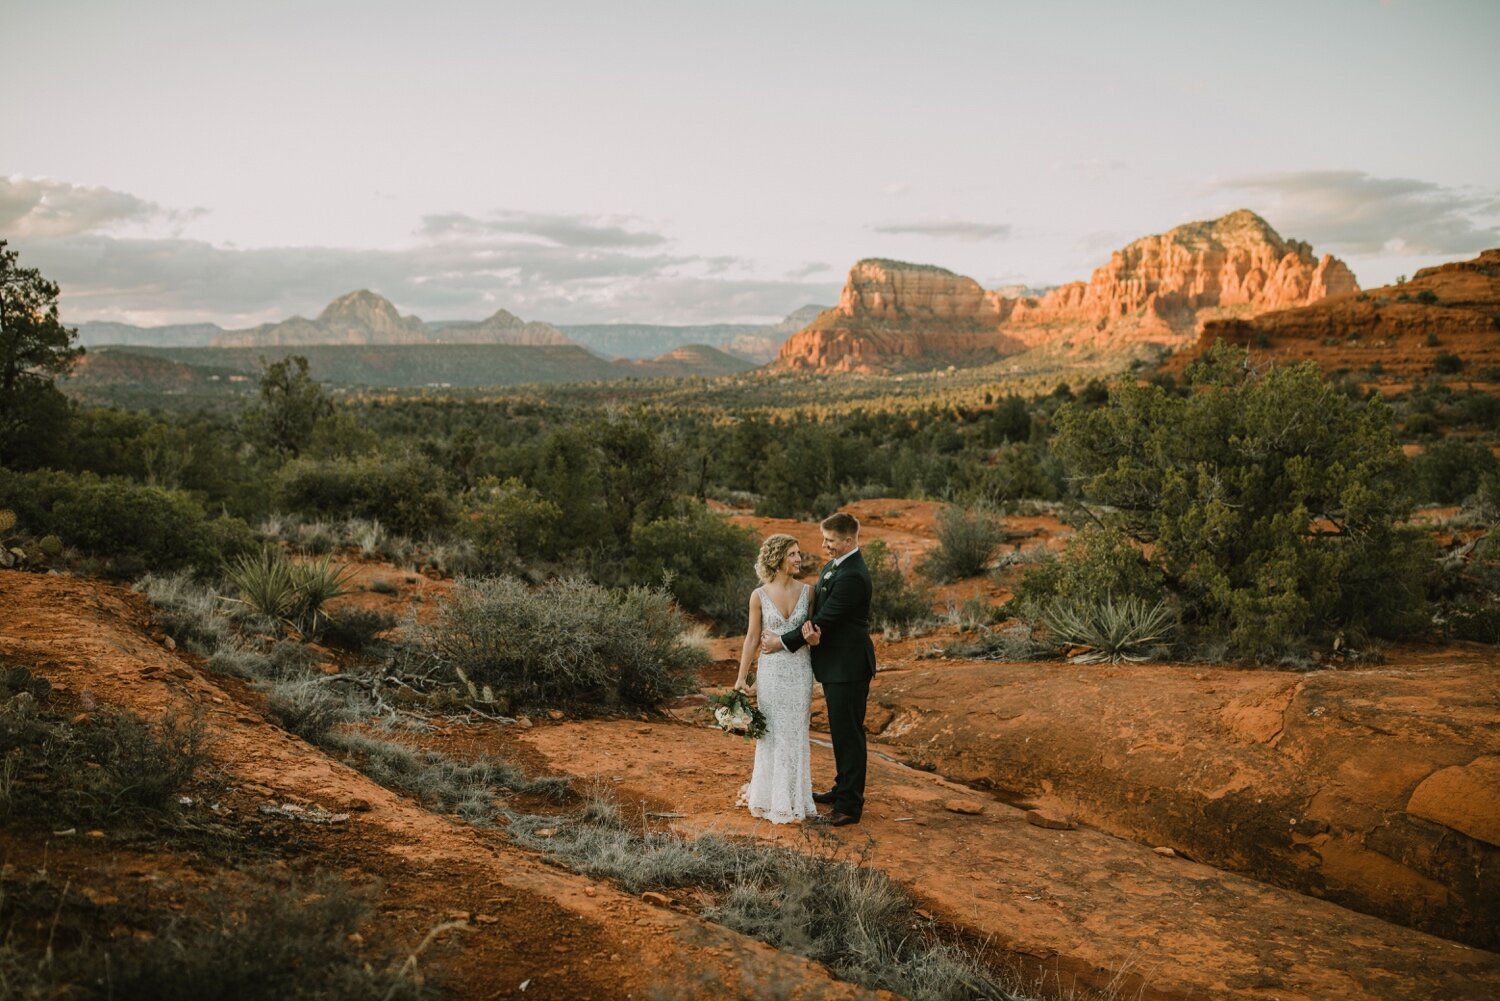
(518, 720), (1500, 1001)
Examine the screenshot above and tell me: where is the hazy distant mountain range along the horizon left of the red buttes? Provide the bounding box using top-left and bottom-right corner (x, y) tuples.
(78, 290), (822, 365)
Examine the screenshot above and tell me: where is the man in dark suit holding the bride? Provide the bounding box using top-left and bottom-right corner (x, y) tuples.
(761, 512), (875, 827)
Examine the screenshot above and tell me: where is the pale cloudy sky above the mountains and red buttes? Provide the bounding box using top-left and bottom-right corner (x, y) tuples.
(0, 0), (1500, 326)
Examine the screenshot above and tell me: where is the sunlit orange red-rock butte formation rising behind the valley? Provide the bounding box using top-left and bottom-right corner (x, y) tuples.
(777, 210), (1359, 371)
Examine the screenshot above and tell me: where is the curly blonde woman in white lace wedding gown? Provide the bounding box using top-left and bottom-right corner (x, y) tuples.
(735, 534), (818, 824)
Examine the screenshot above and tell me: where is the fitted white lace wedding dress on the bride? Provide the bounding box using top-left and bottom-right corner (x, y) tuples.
(738, 584), (818, 824)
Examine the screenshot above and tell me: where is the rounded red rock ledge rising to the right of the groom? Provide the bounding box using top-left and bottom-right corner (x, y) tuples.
(872, 654), (1500, 948)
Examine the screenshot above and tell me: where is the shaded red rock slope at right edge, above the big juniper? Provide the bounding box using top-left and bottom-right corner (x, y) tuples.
(1164, 249), (1500, 383)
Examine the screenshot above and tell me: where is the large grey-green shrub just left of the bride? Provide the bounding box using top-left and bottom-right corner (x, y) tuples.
(429, 578), (704, 705)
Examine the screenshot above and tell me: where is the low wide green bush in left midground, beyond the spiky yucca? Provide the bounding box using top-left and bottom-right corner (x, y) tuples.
(276, 455), (453, 536)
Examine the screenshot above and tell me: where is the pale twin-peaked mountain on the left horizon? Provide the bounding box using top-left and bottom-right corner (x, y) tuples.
(213, 288), (569, 348)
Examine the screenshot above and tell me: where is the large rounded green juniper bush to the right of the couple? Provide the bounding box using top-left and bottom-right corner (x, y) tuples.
(1055, 345), (1431, 657)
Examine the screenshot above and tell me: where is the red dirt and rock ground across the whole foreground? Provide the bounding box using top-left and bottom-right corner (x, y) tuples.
(0, 501), (1500, 1001)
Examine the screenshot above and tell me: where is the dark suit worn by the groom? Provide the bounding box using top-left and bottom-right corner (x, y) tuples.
(782, 549), (875, 819)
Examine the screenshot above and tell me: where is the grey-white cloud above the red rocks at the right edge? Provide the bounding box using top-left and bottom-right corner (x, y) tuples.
(1215, 170), (1500, 255)
